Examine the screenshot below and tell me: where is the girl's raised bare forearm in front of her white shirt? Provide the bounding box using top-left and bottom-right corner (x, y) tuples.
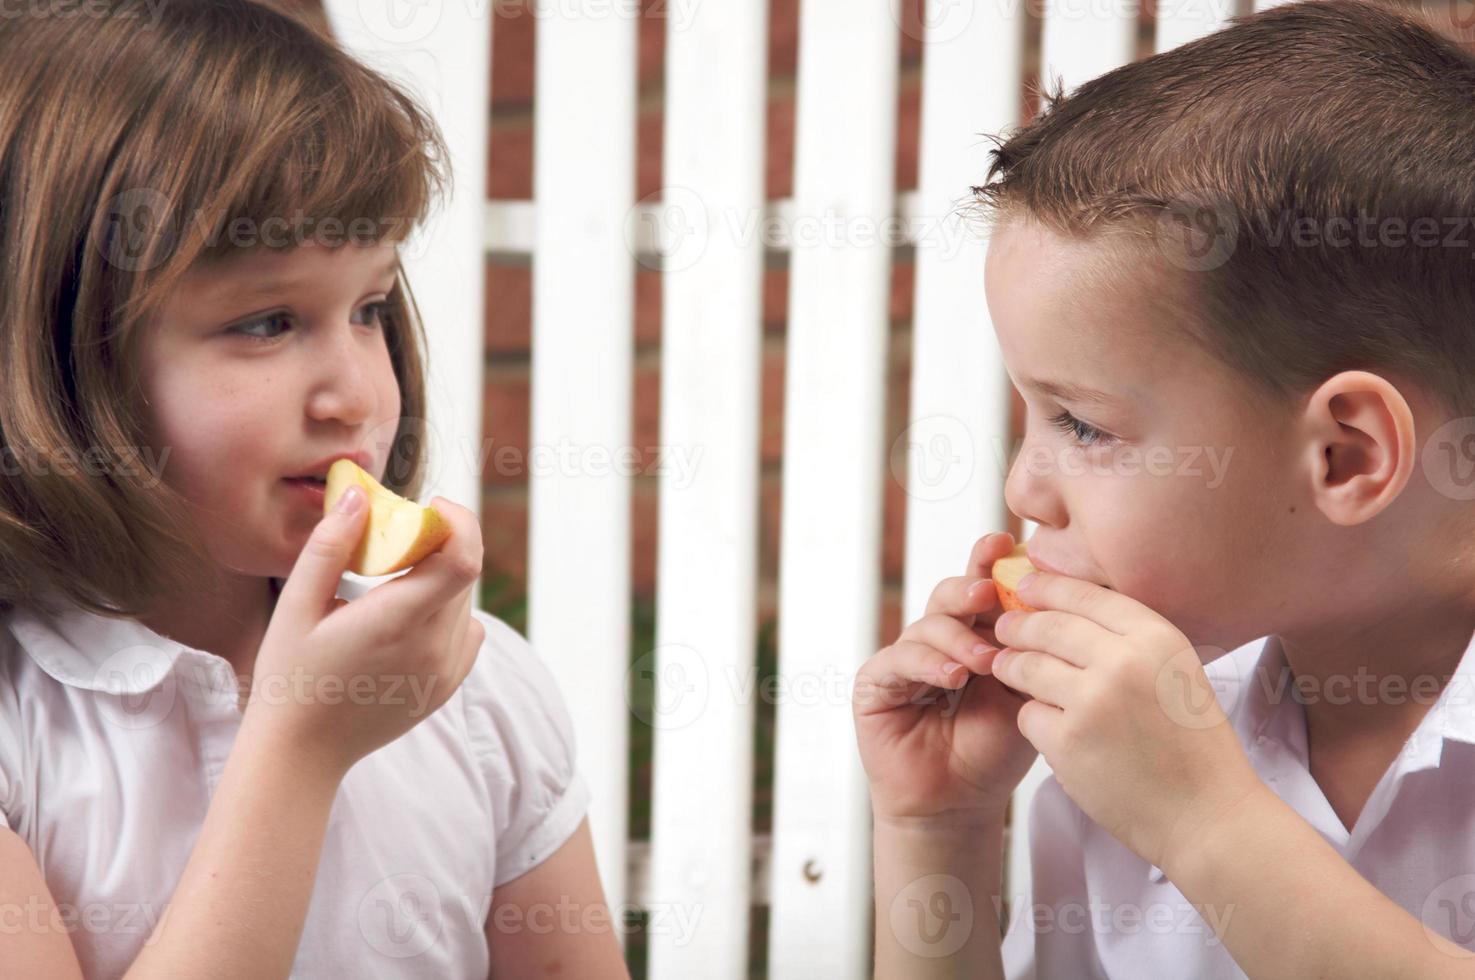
(125, 710), (342, 980)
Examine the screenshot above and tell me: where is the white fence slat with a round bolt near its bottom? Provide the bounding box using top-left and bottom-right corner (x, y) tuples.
(768, 0), (900, 980)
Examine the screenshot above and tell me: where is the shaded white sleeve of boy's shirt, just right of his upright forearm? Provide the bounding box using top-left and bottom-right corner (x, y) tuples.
(1003, 775), (1103, 980)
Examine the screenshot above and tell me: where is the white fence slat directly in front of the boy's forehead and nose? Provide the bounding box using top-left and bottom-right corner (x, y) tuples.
(892, 0), (1022, 623)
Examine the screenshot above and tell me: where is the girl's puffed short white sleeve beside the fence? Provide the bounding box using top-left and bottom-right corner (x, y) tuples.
(466, 610), (590, 886)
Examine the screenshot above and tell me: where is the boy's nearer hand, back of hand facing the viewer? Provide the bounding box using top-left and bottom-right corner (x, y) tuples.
(993, 571), (1263, 868)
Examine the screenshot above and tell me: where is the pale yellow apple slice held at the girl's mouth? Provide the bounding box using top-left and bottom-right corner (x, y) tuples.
(323, 459), (451, 576)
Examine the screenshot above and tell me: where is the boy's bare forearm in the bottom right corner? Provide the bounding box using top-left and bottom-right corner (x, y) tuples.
(1162, 785), (1475, 980)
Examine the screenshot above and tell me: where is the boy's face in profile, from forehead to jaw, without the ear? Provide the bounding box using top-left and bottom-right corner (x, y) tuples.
(985, 221), (1297, 660)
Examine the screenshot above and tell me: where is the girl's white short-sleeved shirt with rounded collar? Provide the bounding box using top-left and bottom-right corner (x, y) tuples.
(0, 576), (589, 980)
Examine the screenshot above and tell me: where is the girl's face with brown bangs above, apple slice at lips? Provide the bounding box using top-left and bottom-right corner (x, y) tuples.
(139, 245), (400, 577)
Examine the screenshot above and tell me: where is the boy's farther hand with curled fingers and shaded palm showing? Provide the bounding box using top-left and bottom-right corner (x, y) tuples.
(851, 533), (1037, 822)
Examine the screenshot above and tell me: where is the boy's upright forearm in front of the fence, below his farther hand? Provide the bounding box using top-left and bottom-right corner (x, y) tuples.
(873, 815), (1004, 980)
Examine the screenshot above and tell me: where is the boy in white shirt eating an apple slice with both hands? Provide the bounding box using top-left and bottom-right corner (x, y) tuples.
(854, 0), (1475, 980)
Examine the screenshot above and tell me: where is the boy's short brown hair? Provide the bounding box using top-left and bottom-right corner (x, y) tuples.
(974, 0), (1475, 415)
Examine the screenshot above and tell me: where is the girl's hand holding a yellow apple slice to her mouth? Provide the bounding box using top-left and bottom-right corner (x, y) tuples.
(246, 490), (485, 778)
